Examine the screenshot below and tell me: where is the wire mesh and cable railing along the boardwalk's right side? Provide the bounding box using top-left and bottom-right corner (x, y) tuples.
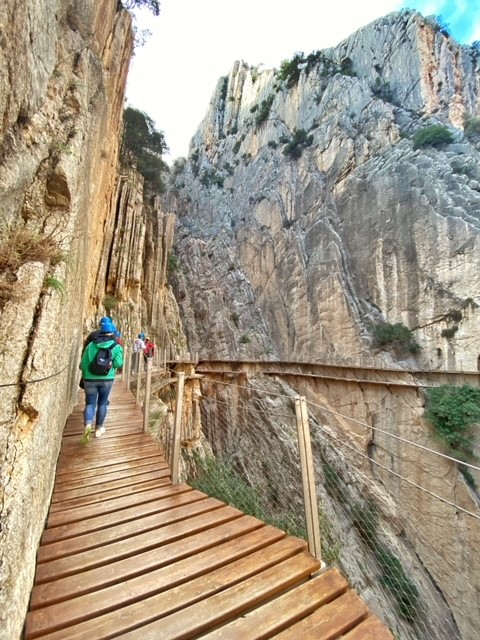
(123, 363), (480, 640)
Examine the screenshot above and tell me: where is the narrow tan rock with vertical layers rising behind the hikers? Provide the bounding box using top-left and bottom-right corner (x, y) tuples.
(100, 163), (187, 358)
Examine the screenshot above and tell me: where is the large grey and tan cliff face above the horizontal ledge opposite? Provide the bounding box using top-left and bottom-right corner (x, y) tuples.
(169, 12), (480, 369)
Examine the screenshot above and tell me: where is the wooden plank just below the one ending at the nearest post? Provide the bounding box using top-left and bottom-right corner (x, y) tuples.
(202, 569), (349, 640)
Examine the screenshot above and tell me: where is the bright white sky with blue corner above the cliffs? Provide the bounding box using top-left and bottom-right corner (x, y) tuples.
(126, 0), (480, 164)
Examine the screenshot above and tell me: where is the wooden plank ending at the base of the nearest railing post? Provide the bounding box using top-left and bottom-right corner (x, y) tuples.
(116, 551), (320, 640)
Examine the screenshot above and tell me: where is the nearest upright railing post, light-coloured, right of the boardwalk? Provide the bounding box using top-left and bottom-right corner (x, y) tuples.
(295, 396), (325, 569)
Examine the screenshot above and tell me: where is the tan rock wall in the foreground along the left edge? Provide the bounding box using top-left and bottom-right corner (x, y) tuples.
(0, 0), (133, 640)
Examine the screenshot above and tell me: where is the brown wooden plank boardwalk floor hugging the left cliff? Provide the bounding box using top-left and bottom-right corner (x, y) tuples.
(24, 380), (393, 640)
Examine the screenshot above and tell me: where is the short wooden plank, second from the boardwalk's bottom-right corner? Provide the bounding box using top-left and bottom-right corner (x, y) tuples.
(273, 590), (368, 640)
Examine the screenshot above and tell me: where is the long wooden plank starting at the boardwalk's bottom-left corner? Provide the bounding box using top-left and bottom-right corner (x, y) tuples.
(25, 516), (285, 640)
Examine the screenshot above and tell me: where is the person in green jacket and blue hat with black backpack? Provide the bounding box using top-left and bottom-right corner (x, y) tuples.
(80, 323), (123, 444)
